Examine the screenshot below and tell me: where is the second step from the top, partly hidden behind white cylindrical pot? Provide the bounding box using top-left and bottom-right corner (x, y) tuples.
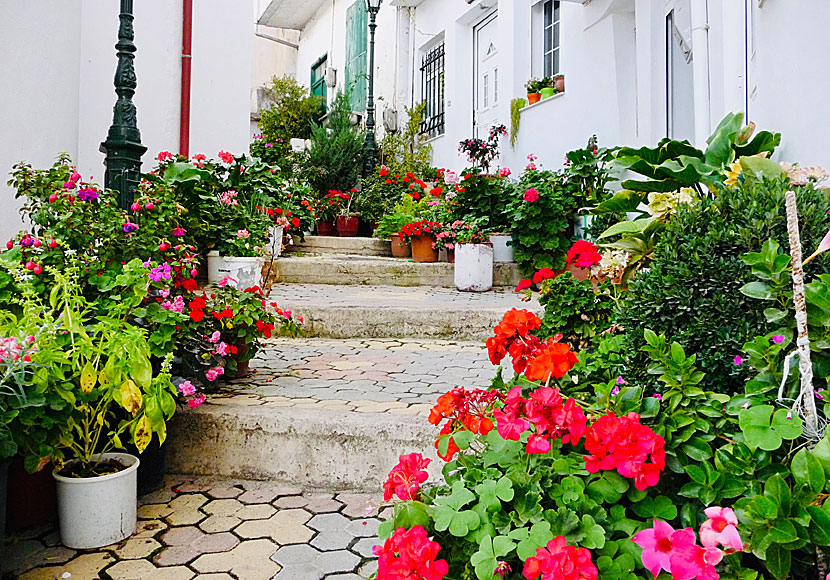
(274, 254), (521, 288)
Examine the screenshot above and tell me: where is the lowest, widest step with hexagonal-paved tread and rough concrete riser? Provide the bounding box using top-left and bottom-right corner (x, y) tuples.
(168, 338), (512, 491)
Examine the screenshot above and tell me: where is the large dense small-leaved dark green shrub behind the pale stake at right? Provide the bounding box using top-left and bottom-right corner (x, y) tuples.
(615, 179), (830, 393)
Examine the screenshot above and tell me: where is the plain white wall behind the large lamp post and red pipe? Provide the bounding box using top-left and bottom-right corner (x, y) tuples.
(0, 0), (254, 239)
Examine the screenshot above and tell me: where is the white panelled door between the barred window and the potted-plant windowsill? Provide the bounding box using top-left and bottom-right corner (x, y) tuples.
(473, 13), (500, 139)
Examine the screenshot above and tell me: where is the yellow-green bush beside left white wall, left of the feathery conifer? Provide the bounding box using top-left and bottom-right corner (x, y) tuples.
(257, 76), (324, 165)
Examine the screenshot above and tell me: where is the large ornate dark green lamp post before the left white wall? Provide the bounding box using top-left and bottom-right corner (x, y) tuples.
(101, 0), (147, 209)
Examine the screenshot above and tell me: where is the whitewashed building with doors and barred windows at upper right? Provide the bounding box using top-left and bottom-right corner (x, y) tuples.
(260, 0), (830, 169)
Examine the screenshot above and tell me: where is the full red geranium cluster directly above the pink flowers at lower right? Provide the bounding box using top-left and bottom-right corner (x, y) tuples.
(585, 413), (666, 491)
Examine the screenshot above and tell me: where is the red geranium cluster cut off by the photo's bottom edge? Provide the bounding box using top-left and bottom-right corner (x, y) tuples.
(372, 526), (449, 580)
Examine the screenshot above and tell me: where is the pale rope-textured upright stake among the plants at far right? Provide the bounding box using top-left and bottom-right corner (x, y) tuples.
(779, 191), (826, 447)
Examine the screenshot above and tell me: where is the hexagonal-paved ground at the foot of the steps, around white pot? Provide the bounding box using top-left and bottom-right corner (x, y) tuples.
(2, 477), (388, 580)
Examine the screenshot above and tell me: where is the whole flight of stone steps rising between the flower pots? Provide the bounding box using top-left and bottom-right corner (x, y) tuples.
(170, 237), (540, 491)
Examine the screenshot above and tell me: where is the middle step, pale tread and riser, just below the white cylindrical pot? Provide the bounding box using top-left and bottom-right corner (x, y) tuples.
(270, 284), (542, 341)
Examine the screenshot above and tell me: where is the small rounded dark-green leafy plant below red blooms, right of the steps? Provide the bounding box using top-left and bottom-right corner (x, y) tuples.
(539, 272), (613, 350)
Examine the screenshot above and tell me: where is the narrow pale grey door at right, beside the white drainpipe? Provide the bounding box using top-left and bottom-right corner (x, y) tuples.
(666, 0), (695, 143)
